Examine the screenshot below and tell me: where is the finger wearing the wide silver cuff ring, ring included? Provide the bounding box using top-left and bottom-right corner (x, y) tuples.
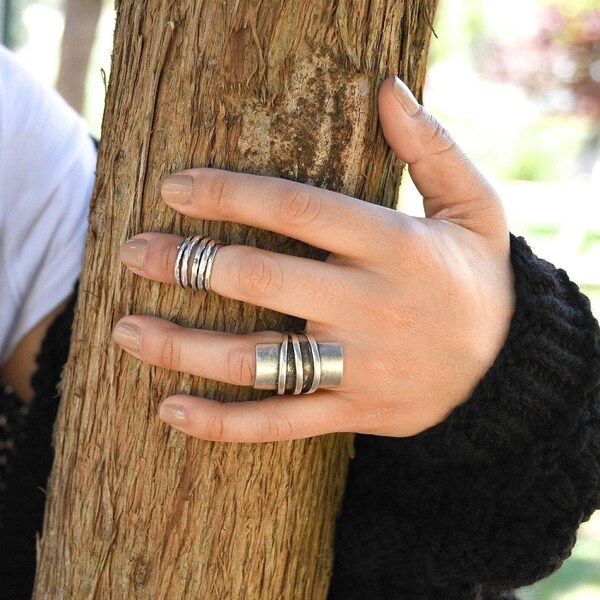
(113, 315), (344, 394)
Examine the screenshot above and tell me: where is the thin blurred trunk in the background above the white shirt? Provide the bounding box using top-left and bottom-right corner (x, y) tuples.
(56, 0), (102, 112)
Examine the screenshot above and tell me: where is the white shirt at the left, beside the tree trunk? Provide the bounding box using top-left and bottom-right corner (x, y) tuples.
(0, 46), (96, 366)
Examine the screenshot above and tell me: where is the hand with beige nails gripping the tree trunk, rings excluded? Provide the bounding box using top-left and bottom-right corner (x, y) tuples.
(114, 78), (514, 442)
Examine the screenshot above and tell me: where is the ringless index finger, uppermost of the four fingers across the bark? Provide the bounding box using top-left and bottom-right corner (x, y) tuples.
(161, 168), (406, 259)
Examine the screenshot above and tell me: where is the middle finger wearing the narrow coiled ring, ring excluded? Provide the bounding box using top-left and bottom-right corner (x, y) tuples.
(121, 233), (366, 323)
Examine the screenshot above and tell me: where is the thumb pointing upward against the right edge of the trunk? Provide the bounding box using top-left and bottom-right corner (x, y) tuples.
(379, 77), (507, 238)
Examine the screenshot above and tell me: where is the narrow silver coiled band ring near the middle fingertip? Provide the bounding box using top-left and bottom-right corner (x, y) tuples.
(174, 235), (223, 292)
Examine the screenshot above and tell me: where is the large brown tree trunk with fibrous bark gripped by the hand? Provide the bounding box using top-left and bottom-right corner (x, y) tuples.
(34, 0), (436, 600)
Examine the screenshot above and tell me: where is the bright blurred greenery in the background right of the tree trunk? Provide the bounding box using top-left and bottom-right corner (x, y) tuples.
(426, 0), (600, 600)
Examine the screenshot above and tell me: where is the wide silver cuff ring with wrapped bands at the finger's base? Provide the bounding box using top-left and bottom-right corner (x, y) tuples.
(254, 331), (344, 394)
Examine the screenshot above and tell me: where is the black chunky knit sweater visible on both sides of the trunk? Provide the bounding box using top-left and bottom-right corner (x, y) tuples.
(0, 238), (600, 600)
